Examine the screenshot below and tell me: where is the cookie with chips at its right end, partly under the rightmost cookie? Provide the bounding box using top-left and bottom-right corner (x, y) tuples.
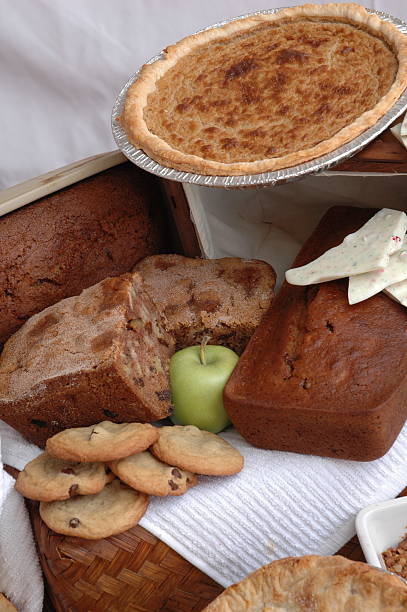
(109, 451), (198, 496)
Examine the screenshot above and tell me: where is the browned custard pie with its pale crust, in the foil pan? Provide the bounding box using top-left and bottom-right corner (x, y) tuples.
(121, 4), (407, 175)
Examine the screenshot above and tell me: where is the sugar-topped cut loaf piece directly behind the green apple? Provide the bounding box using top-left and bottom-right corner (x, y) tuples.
(134, 255), (276, 354)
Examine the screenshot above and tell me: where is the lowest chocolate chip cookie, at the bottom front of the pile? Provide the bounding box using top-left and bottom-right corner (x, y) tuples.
(40, 478), (149, 540)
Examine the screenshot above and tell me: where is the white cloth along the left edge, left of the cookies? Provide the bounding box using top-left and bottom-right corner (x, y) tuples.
(0, 421), (44, 612)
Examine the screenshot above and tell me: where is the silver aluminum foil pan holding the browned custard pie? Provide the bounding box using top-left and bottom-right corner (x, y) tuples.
(112, 8), (407, 188)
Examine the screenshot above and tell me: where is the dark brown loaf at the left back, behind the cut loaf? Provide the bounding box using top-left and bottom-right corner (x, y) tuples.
(0, 163), (169, 342)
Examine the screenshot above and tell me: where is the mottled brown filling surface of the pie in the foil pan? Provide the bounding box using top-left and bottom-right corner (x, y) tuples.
(144, 18), (398, 163)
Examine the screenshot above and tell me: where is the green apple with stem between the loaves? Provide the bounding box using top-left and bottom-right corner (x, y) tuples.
(170, 337), (239, 433)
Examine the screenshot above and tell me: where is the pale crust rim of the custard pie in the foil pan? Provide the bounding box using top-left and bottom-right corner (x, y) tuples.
(121, 3), (407, 176)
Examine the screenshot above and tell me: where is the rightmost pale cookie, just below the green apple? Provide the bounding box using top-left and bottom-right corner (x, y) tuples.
(151, 425), (243, 476)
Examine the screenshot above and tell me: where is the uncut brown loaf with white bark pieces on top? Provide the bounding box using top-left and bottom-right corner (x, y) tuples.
(224, 207), (407, 461)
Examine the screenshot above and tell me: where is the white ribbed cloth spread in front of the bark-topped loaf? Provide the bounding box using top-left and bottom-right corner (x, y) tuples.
(141, 424), (407, 587)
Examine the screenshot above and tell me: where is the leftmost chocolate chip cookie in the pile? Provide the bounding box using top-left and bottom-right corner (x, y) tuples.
(15, 453), (114, 502)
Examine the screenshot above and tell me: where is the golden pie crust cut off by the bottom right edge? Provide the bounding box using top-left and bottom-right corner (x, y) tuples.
(204, 555), (407, 612)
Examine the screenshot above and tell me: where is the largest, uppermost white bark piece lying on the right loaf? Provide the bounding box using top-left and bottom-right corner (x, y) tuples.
(285, 208), (407, 285)
